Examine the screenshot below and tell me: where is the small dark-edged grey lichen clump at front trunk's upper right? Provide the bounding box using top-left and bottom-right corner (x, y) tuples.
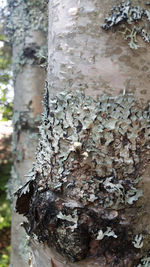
(102, 1), (150, 49)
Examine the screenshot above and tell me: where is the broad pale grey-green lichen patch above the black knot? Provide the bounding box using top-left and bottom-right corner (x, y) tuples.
(35, 92), (150, 208)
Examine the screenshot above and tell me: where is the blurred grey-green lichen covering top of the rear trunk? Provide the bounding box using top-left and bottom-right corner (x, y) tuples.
(7, 0), (48, 76)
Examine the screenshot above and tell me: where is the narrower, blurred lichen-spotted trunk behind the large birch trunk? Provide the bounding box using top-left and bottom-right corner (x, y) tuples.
(8, 0), (47, 267)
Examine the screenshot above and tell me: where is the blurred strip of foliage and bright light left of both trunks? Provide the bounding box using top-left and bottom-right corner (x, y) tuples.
(0, 0), (13, 267)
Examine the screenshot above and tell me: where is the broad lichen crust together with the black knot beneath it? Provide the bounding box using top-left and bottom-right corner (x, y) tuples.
(16, 92), (150, 263)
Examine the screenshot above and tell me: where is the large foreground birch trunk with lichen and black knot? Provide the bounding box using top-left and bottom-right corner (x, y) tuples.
(17, 0), (150, 267)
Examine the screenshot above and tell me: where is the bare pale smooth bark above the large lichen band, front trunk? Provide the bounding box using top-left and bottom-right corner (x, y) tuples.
(48, 0), (150, 101)
